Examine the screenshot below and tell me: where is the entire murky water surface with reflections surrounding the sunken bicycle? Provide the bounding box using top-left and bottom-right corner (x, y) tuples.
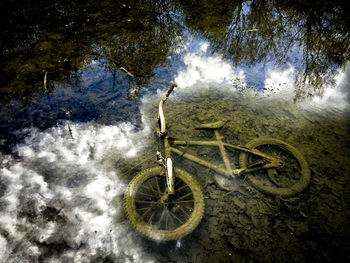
(0, 1), (350, 262)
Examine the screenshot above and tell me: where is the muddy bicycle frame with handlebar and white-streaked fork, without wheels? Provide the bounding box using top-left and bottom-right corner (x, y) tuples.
(158, 82), (283, 194)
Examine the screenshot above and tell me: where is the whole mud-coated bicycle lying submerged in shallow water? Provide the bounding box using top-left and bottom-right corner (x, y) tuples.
(123, 82), (310, 241)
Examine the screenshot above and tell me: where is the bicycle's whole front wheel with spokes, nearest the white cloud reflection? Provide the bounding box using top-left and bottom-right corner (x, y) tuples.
(123, 167), (204, 241)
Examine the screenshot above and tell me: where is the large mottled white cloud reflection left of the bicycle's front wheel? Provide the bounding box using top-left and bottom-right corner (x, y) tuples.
(0, 120), (154, 262)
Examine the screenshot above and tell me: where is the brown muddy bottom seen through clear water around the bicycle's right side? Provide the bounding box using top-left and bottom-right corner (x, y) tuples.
(121, 90), (350, 262)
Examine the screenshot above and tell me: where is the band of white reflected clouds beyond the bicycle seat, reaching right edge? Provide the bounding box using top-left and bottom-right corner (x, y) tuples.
(175, 41), (350, 110)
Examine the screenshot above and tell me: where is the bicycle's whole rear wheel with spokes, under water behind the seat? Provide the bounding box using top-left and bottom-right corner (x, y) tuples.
(239, 138), (311, 197)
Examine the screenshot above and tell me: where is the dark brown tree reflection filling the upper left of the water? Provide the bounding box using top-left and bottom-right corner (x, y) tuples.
(0, 0), (183, 106)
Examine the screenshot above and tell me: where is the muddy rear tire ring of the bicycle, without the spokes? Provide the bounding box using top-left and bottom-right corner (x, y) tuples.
(239, 138), (311, 197)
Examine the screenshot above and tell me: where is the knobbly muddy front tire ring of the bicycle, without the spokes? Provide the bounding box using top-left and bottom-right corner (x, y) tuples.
(123, 167), (204, 241)
